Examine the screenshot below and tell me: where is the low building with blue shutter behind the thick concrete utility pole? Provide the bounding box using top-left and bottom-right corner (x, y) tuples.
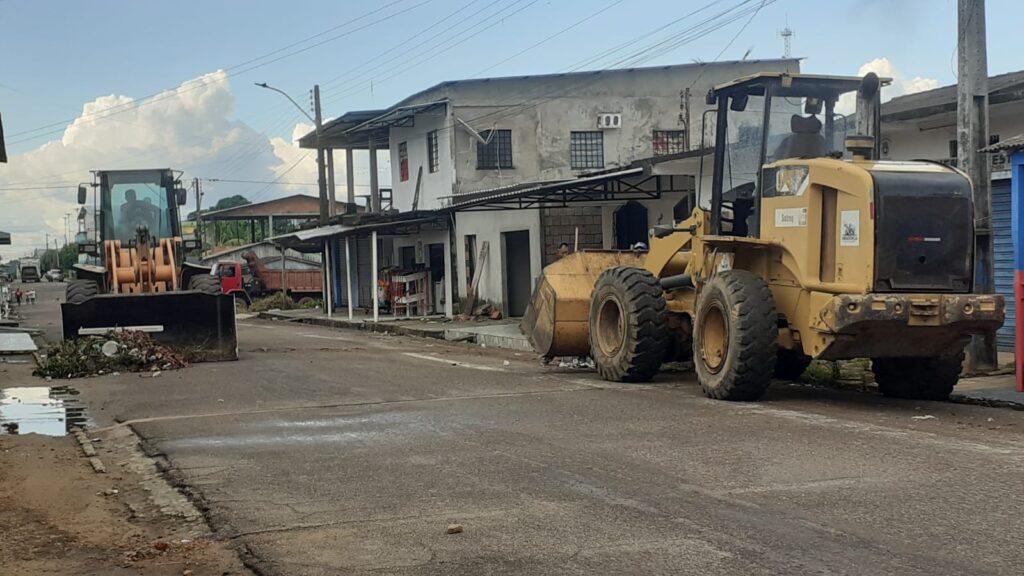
(881, 72), (1024, 352)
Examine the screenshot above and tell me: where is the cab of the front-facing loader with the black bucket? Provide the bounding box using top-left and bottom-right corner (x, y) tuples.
(89, 169), (184, 245)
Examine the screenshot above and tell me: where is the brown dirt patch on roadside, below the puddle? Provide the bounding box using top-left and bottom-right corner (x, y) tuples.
(0, 428), (250, 576)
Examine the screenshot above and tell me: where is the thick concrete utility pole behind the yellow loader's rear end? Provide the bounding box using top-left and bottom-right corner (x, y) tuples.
(956, 0), (997, 371)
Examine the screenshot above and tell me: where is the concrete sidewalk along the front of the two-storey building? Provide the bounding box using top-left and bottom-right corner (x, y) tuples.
(258, 310), (534, 352)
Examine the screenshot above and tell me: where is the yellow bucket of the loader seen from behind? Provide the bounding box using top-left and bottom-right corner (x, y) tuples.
(519, 250), (644, 358)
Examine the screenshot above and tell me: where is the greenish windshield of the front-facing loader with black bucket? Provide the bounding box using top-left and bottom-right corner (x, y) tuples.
(101, 171), (174, 243)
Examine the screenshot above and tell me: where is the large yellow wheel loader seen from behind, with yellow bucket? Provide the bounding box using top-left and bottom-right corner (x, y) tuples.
(522, 73), (1005, 401)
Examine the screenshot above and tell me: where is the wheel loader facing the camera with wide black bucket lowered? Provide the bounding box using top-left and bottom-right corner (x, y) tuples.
(60, 169), (238, 362)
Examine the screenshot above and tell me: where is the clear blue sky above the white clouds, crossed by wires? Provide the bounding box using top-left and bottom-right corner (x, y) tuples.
(0, 0), (1024, 153)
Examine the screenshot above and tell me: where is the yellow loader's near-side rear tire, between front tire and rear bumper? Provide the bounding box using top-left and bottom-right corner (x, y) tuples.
(693, 270), (778, 401)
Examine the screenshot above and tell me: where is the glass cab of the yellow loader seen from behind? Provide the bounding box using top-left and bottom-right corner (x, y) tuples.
(699, 73), (887, 238)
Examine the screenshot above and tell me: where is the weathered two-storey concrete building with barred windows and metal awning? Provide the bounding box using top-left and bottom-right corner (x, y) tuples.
(300, 59), (799, 316)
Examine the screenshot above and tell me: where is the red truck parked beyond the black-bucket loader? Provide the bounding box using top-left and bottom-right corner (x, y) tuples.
(213, 251), (324, 302)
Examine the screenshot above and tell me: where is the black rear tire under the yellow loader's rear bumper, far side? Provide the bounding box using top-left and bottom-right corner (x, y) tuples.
(871, 351), (964, 401)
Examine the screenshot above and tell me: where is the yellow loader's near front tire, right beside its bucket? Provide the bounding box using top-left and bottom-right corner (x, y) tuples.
(590, 266), (669, 382)
